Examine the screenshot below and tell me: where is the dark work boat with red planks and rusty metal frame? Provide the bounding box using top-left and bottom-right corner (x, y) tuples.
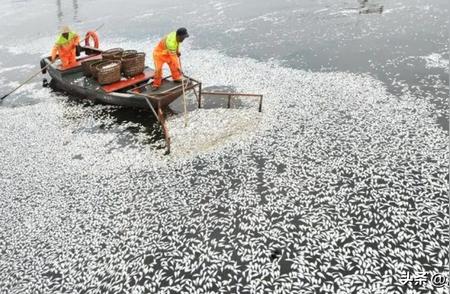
(41, 46), (263, 154)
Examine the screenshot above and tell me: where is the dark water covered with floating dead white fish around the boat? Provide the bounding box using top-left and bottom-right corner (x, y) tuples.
(0, 0), (450, 293)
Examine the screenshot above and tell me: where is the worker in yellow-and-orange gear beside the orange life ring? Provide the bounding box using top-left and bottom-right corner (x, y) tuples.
(51, 26), (80, 69)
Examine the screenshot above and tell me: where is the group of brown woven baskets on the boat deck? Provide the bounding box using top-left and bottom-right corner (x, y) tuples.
(82, 48), (145, 85)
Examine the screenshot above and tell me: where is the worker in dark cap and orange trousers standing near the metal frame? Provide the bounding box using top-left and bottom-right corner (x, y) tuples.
(152, 28), (189, 90)
